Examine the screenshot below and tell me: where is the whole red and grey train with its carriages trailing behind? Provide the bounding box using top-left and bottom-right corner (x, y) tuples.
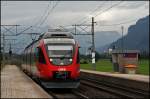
(22, 31), (80, 88)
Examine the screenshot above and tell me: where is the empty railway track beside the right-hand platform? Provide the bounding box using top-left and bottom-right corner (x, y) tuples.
(80, 78), (149, 98)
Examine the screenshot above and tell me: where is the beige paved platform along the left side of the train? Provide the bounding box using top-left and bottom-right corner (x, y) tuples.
(1, 65), (52, 98)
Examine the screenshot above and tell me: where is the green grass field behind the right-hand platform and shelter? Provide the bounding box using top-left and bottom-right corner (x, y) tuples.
(80, 59), (149, 75)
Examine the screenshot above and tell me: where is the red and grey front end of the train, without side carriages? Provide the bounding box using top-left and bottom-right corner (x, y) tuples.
(39, 34), (80, 88)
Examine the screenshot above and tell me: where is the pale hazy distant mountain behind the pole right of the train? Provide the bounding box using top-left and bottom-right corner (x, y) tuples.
(74, 31), (121, 54)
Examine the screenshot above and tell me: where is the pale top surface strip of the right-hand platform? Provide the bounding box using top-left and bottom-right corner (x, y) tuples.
(81, 69), (149, 82)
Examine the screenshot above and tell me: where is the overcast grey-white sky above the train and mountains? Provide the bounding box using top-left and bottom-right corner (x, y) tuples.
(1, 1), (149, 53)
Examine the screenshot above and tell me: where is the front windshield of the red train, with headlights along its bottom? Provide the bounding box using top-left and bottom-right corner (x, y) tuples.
(47, 45), (73, 65)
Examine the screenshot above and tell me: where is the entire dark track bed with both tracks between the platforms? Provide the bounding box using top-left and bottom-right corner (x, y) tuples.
(25, 71), (149, 99)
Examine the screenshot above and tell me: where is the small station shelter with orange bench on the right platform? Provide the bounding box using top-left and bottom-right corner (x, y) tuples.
(112, 50), (139, 74)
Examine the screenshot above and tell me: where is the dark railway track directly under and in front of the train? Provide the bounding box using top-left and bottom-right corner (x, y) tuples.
(40, 81), (118, 99)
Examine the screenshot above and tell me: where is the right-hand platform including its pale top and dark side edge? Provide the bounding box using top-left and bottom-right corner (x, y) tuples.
(80, 69), (149, 91)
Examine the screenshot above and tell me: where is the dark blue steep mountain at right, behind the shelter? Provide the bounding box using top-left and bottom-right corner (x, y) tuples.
(109, 16), (149, 53)
